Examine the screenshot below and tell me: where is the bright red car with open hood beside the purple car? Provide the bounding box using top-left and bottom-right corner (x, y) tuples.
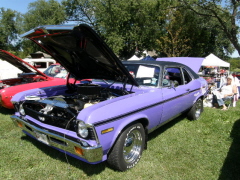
(0, 49), (74, 109)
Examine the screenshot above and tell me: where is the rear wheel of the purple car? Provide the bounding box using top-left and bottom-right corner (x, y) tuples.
(187, 98), (203, 120)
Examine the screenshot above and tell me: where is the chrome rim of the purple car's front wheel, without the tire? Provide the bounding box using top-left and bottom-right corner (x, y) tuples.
(123, 129), (142, 163)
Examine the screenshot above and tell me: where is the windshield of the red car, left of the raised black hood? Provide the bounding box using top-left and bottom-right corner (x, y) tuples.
(43, 64), (68, 79)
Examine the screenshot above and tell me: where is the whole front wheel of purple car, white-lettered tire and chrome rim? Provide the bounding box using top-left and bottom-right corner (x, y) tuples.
(107, 123), (145, 171)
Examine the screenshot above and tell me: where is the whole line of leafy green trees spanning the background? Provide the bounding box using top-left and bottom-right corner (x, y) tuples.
(0, 0), (239, 59)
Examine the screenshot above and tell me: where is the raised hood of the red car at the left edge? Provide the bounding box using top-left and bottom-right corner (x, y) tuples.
(0, 49), (47, 77)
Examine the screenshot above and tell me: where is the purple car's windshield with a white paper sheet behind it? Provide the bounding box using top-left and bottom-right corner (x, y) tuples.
(124, 64), (160, 87)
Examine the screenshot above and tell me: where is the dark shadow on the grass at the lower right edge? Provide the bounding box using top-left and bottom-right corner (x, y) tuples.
(218, 119), (240, 180)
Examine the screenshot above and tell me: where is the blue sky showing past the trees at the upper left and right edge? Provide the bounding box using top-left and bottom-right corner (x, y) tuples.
(0, 0), (239, 57)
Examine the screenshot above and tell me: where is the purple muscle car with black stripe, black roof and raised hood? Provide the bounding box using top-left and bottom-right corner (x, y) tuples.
(11, 25), (207, 171)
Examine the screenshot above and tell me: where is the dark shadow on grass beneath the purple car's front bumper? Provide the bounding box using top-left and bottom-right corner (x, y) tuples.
(21, 135), (107, 176)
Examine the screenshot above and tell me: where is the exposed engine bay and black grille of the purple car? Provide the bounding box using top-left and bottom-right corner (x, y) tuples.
(19, 84), (130, 130)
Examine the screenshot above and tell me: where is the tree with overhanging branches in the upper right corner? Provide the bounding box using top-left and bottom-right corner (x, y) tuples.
(180, 0), (240, 54)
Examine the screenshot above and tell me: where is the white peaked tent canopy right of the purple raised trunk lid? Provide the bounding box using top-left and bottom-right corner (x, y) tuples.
(202, 53), (230, 67)
